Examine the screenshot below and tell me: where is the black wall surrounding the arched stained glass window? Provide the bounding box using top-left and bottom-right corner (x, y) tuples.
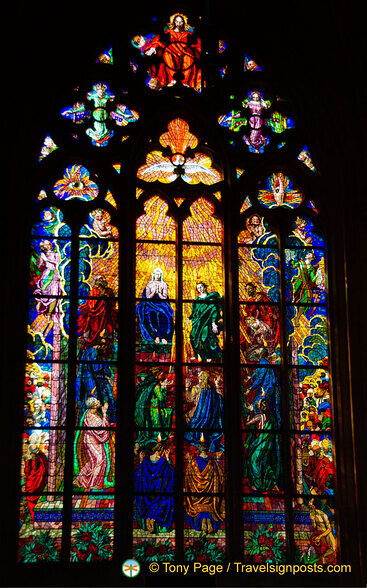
(0, 0), (367, 586)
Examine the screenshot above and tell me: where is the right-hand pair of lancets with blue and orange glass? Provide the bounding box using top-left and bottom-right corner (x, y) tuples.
(238, 200), (337, 563)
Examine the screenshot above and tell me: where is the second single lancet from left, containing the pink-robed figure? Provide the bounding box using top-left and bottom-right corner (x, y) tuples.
(70, 224), (119, 548)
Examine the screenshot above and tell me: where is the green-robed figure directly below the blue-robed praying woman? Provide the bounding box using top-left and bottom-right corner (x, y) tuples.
(135, 367), (172, 448)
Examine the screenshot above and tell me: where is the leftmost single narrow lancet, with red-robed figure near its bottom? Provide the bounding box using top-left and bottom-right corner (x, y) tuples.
(18, 207), (71, 561)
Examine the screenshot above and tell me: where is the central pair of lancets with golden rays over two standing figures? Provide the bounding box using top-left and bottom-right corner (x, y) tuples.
(133, 185), (225, 559)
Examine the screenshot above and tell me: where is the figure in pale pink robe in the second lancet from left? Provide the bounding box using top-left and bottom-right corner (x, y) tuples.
(74, 397), (114, 490)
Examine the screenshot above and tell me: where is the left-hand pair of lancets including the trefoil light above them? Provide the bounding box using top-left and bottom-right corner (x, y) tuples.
(18, 178), (119, 563)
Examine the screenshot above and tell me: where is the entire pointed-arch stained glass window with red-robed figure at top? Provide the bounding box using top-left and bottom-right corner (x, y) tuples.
(18, 3), (348, 580)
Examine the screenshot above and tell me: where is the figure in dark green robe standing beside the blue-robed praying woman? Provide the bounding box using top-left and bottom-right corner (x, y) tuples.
(186, 282), (222, 361)
